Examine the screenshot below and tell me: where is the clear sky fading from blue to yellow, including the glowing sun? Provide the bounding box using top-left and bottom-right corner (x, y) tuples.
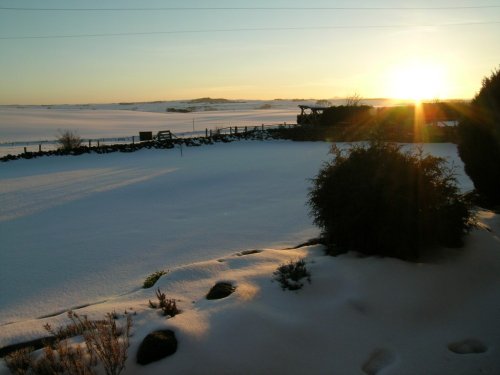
(0, 0), (500, 104)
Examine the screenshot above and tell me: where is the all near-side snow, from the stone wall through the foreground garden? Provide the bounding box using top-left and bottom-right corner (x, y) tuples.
(0, 112), (500, 375)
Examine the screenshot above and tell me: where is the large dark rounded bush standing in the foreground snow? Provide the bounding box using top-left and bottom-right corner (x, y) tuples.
(309, 143), (471, 260)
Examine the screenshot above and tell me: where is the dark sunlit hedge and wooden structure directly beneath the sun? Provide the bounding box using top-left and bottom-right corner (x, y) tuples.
(292, 101), (470, 142)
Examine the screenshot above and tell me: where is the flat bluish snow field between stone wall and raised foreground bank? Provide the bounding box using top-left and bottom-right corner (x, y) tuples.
(0, 142), (328, 323)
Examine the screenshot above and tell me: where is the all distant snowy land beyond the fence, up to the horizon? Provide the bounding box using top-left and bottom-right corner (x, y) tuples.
(0, 99), (392, 156)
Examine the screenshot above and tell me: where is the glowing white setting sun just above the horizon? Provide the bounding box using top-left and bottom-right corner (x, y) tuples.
(389, 62), (446, 101)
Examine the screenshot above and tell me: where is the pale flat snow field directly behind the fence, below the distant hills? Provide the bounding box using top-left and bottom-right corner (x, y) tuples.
(0, 108), (297, 156)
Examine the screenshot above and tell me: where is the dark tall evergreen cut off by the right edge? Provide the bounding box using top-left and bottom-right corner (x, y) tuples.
(458, 69), (500, 206)
